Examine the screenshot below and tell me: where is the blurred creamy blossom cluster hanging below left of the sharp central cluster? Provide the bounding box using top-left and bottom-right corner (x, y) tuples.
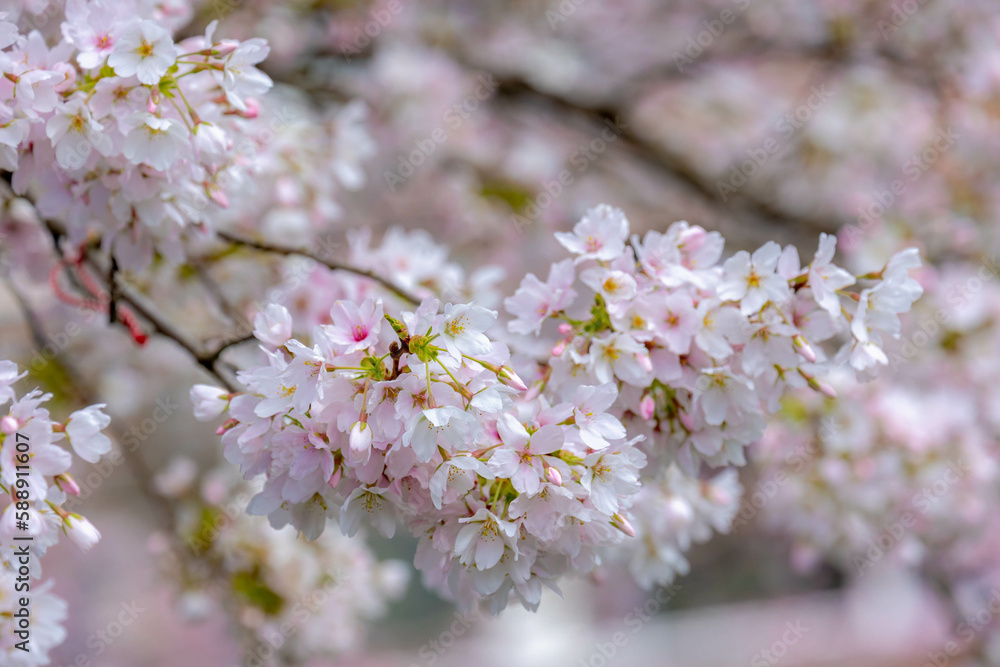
(150, 457), (410, 664)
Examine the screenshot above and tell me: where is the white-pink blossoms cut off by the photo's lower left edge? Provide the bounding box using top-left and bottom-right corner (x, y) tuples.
(0, 361), (111, 665)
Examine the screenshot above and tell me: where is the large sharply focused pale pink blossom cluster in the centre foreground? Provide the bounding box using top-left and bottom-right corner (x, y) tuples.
(192, 299), (645, 611)
